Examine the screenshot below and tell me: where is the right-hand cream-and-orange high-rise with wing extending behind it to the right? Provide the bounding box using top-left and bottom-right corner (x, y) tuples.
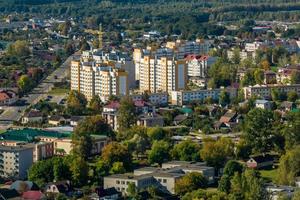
(133, 40), (210, 92)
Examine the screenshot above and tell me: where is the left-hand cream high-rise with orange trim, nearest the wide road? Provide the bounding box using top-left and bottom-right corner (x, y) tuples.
(71, 61), (128, 101)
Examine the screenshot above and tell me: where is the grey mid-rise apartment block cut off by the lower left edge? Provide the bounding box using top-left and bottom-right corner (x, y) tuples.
(0, 145), (33, 179)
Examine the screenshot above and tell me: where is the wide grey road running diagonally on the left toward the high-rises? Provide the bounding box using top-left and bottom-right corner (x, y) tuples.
(0, 56), (72, 129)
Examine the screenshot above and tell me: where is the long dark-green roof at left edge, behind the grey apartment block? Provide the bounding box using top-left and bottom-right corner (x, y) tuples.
(0, 128), (71, 142)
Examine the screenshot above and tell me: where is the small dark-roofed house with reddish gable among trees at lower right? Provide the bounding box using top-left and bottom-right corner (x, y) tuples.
(246, 154), (274, 169)
